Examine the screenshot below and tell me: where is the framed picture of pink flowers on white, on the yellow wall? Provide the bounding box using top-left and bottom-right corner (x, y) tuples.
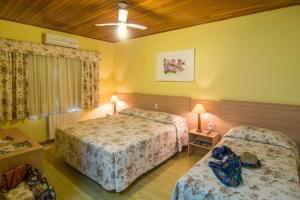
(156, 49), (195, 81)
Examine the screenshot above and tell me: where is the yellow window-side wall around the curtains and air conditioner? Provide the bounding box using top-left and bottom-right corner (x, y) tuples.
(0, 20), (114, 141)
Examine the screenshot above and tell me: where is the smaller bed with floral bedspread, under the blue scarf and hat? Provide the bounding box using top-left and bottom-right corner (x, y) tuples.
(172, 126), (300, 200)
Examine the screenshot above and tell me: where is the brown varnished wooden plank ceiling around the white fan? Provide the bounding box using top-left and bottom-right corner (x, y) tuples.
(0, 0), (300, 42)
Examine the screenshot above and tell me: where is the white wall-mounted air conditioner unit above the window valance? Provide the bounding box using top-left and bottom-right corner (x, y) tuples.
(43, 33), (78, 49)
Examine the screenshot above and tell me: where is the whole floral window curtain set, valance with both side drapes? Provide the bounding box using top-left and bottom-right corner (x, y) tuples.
(0, 38), (100, 117)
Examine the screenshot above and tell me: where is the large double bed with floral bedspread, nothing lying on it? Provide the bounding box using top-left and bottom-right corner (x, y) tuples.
(55, 108), (188, 192)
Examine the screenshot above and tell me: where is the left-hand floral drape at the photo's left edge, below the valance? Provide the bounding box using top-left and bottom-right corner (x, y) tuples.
(0, 51), (28, 121)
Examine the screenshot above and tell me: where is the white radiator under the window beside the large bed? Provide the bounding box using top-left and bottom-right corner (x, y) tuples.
(48, 111), (83, 140)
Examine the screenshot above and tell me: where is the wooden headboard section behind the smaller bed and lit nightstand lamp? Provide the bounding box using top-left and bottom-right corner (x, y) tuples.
(191, 99), (300, 146)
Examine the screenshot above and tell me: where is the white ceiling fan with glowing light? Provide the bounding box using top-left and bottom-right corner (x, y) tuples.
(95, 1), (147, 39)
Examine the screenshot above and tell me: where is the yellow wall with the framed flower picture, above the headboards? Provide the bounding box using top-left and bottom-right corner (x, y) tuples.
(114, 6), (300, 104)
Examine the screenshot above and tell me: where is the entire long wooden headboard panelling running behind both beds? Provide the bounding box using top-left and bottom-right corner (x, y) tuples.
(117, 93), (300, 146)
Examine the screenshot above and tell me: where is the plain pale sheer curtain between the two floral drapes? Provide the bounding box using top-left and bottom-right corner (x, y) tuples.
(28, 55), (82, 115)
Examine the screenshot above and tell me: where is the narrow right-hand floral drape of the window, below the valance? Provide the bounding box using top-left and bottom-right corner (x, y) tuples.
(81, 60), (99, 109)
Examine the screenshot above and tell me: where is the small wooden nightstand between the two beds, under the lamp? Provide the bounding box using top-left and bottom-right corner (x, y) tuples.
(188, 129), (220, 155)
